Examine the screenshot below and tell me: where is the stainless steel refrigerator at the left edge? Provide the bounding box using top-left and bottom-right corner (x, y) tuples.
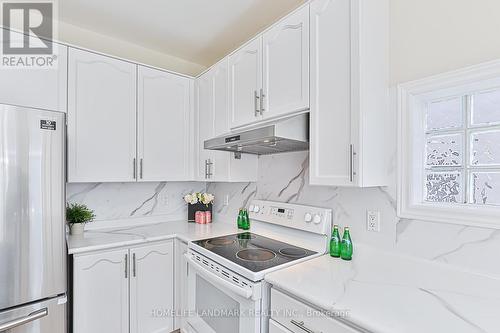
(0, 104), (66, 333)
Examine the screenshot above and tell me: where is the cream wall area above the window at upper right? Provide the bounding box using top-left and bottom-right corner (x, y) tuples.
(390, 0), (500, 85)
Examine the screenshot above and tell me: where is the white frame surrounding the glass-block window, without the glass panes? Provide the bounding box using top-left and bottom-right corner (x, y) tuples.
(397, 60), (500, 229)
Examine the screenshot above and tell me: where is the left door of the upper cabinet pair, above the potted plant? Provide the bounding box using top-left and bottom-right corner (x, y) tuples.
(68, 48), (136, 182)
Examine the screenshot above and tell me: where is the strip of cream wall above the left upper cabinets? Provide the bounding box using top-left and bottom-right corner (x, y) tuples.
(58, 22), (205, 76)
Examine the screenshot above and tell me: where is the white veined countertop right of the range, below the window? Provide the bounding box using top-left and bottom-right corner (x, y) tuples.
(266, 246), (500, 333)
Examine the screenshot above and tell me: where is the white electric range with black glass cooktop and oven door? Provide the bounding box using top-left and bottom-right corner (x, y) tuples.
(184, 200), (332, 333)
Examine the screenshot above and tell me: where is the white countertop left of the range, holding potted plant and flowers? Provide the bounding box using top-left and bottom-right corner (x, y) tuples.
(67, 221), (238, 254)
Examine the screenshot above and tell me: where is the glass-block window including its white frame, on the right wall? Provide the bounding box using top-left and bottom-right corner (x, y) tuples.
(398, 62), (500, 227)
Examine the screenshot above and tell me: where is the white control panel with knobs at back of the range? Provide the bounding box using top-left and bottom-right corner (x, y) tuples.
(248, 200), (332, 234)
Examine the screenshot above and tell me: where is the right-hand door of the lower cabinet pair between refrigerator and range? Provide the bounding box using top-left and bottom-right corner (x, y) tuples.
(130, 241), (174, 333)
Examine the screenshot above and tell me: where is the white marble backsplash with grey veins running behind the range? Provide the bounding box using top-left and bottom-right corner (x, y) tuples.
(66, 152), (500, 277)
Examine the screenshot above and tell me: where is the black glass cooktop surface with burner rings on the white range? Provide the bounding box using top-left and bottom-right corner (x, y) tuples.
(193, 232), (316, 272)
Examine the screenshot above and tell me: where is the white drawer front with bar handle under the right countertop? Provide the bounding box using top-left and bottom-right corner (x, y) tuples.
(271, 289), (359, 333)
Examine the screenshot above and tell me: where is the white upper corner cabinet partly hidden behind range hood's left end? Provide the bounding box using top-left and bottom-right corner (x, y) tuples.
(196, 59), (258, 181)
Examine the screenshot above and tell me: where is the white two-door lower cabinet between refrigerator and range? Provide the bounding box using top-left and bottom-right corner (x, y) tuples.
(73, 241), (174, 333)
